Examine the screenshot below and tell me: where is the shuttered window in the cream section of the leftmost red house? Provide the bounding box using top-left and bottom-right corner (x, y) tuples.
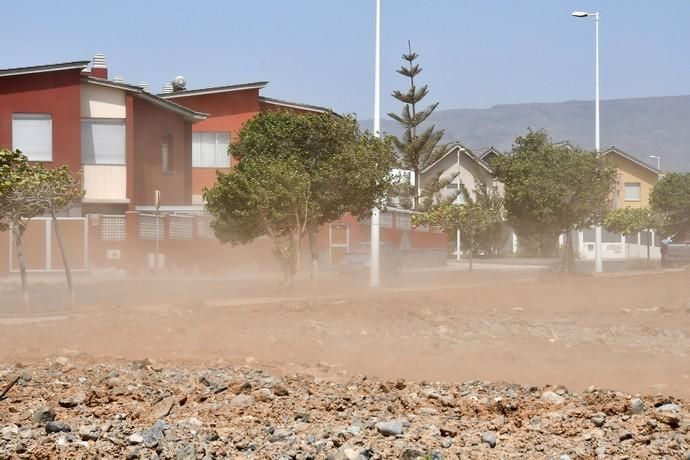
(81, 119), (126, 165)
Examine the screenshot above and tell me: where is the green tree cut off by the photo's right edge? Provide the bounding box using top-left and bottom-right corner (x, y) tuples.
(649, 173), (690, 234)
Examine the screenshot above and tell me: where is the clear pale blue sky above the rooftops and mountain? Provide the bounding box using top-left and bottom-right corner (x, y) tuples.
(0, 0), (690, 118)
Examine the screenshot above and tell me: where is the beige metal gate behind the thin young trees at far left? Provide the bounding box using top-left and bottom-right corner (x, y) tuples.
(9, 217), (89, 272)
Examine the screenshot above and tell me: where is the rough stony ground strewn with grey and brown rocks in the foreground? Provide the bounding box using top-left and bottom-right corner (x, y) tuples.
(0, 357), (690, 460)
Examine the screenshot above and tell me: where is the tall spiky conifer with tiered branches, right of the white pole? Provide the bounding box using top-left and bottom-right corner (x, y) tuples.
(388, 41), (448, 208)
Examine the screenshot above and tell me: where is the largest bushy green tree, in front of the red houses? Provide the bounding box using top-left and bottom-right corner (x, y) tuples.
(205, 112), (395, 281)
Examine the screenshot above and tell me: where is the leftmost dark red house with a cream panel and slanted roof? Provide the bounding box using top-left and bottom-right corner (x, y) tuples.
(0, 55), (206, 215)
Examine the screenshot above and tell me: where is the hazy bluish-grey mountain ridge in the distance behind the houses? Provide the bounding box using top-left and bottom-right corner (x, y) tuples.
(362, 96), (690, 171)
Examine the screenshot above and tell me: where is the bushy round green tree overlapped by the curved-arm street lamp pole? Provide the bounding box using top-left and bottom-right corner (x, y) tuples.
(493, 130), (616, 273)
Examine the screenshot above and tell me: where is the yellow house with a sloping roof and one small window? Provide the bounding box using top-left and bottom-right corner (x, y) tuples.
(602, 147), (660, 208)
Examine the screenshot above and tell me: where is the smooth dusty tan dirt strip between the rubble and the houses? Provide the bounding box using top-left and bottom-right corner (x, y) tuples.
(0, 271), (690, 398)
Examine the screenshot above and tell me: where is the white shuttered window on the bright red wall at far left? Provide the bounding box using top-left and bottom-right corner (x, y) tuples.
(12, 113), (53, 161)
